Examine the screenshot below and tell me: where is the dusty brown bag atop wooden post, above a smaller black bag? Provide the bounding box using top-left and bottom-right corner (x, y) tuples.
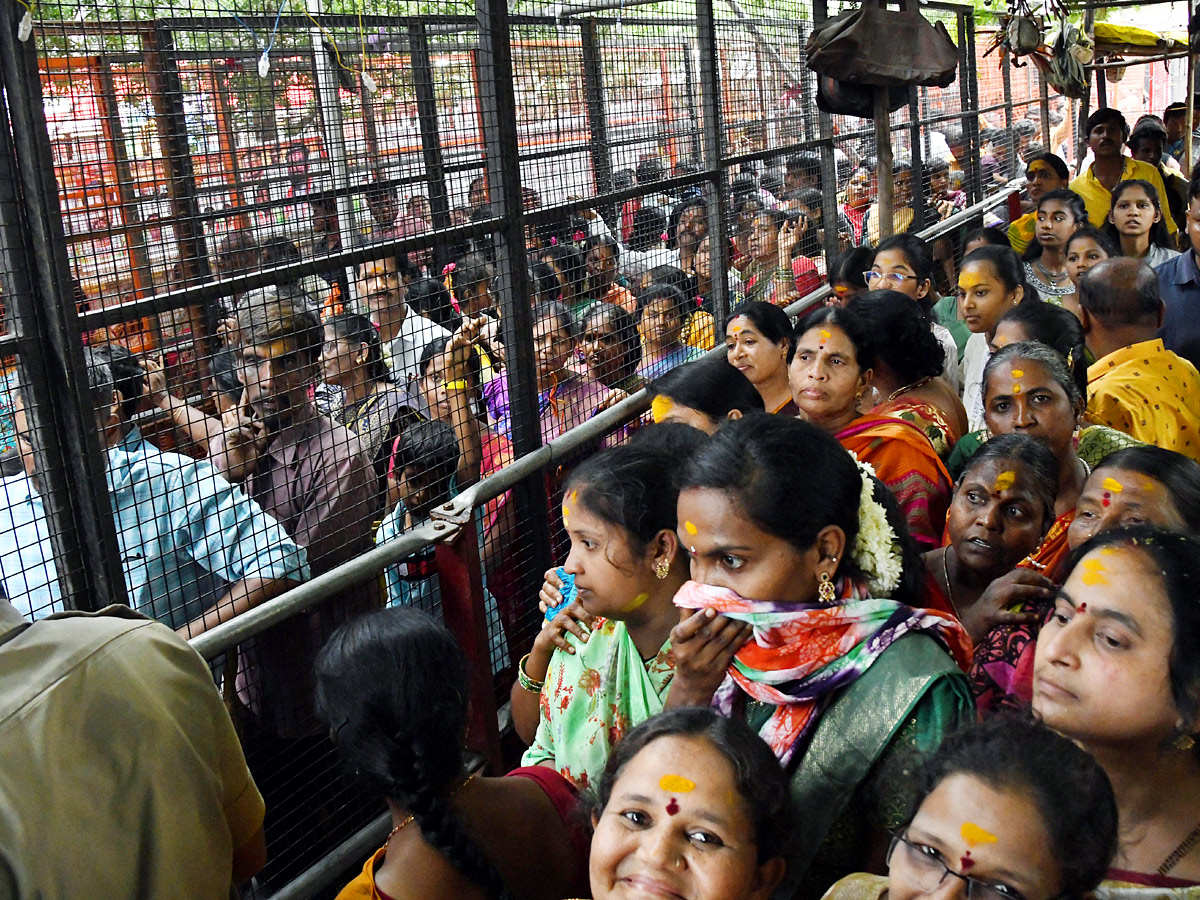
(805, 0), (959, 88)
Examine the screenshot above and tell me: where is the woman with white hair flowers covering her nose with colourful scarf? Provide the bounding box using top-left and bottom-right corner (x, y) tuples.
(668, 415), (974, 898)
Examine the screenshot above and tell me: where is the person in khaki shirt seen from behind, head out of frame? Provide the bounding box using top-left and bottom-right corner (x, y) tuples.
(0, 600), (266, 900)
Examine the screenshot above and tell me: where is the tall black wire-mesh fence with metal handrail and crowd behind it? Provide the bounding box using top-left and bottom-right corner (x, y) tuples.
(0, 0), (1180, 896)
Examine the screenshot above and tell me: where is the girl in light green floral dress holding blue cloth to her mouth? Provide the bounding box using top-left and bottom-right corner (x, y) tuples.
(511, 441), (702, 790)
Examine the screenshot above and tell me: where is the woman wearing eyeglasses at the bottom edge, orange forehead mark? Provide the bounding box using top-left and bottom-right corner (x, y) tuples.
(824, 718), (1117, 900)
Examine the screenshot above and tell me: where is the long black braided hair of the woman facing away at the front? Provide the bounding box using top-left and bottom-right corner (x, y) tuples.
(316, 607), (509, 900)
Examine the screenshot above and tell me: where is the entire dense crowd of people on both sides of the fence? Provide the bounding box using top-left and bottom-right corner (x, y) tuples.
(0, 98), (1200, 900)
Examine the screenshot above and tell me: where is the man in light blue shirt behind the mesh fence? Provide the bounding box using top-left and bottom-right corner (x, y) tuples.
(0, 347), (308, 637)
